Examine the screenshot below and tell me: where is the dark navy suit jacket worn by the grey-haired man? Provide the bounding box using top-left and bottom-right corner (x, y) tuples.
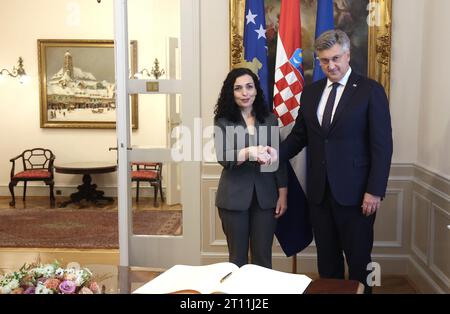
(280, 71), (392, 206)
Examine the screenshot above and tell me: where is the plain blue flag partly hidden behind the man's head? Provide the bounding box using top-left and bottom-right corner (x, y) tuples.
(313, 0), (334, 82)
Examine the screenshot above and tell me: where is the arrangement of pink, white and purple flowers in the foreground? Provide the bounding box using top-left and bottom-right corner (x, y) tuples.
(0, 261), (102, 294)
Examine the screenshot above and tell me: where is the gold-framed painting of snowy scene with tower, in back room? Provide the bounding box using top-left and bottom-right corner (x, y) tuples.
(38, 39), (138, 129)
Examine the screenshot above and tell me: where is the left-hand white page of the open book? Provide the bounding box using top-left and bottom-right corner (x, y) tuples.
(133, 262), (238, 294)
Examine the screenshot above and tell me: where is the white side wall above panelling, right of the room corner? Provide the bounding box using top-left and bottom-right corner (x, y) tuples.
(418, 0), (450, 179)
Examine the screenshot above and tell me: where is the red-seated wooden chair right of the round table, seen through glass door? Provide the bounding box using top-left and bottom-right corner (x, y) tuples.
(131, 162), (164, 207)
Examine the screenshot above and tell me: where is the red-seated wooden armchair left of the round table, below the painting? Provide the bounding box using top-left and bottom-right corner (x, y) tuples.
(9, 148), (55, 206)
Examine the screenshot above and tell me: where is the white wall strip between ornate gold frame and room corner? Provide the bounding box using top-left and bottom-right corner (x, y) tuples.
(390, 0), (424, 163)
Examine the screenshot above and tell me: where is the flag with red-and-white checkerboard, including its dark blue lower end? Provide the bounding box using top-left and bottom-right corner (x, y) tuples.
(273, 0), (313, 256)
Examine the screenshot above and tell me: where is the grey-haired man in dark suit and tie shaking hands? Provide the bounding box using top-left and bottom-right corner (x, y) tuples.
(280, 30), (392, 293)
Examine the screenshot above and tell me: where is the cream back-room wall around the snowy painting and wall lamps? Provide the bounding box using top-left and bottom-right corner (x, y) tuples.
(0, 0), (179, 190)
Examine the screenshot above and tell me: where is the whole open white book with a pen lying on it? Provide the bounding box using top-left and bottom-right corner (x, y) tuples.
(133, 262), (311, 294)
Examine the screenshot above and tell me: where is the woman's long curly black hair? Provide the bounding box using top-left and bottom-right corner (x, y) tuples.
(214, 68), (269, 123)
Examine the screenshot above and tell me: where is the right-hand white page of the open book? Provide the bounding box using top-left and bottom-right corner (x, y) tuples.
(220, 264), (312, 294)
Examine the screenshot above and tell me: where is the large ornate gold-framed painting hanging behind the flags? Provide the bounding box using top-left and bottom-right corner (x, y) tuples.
(229, 0), (392, 96)
